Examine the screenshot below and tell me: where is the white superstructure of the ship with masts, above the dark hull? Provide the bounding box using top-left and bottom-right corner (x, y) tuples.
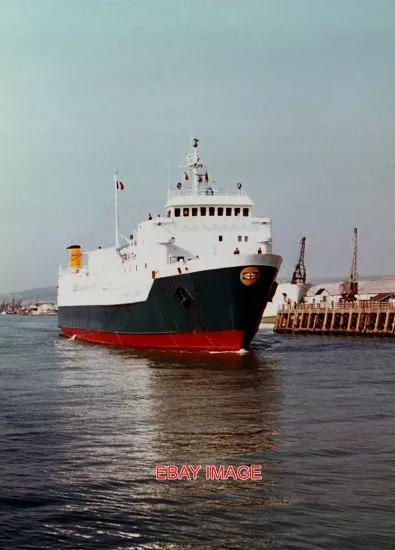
(58, 140), (281, 307)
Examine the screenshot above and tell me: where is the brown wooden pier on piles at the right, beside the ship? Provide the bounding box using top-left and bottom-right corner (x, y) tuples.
(274, 301), (395, 336)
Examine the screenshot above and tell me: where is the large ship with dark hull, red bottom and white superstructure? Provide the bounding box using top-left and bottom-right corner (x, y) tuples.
(57, 138), (282, 351)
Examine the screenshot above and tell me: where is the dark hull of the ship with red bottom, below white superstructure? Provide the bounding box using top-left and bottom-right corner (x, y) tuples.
(58, 265), (277, 349)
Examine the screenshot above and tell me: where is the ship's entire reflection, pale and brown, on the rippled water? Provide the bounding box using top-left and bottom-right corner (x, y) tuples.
(41, 339), (281, 547)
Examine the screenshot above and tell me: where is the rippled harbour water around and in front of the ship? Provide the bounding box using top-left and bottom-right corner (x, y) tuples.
(0, 316), (395, 550)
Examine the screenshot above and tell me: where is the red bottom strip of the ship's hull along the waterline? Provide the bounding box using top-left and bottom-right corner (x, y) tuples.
(59, 326), (245, 351)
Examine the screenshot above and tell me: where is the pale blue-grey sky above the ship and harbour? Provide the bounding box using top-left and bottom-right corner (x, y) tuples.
(0, 0), (395, 292)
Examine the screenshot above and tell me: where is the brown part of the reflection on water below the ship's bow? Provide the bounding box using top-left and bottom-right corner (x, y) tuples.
(145, 354), (280, 464)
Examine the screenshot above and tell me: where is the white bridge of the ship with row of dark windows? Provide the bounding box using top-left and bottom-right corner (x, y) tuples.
(166, 186), (254, 218)
